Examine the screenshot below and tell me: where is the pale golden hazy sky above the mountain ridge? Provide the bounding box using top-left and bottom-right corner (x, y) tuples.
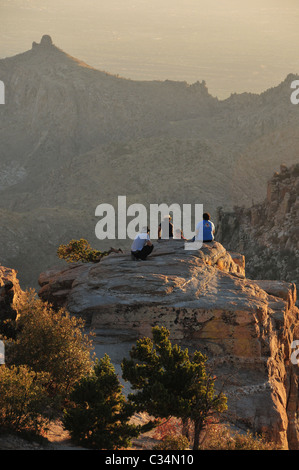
(0, 0), (299, 98)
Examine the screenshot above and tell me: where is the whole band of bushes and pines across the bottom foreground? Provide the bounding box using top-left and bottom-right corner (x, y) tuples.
(0, 291), (282, 450)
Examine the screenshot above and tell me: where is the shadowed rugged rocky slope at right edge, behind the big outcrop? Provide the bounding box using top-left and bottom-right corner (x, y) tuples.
(217, 164), (299, 286)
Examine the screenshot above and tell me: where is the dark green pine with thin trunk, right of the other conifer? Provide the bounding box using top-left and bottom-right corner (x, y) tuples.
(122, 327), (226, 450)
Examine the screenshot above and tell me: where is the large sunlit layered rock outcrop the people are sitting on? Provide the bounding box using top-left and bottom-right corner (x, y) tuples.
(39, 240), (299, 449)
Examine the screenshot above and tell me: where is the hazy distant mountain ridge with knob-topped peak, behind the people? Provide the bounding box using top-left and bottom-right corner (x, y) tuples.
(0, 35), (299, 286)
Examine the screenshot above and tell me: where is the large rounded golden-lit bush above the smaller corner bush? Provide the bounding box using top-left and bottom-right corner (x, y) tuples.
(6, 291), (93, 398)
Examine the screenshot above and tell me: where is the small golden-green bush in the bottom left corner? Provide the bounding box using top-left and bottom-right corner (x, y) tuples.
(0, 365), (49, 434)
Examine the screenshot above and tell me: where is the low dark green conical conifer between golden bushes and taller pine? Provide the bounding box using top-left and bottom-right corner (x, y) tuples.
(63, 355), (140, 449)
